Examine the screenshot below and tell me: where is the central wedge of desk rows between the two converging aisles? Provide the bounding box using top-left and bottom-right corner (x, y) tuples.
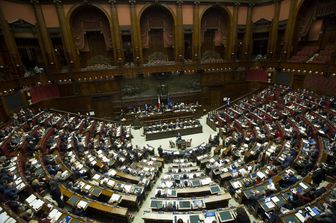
(143, 158), (235, 222)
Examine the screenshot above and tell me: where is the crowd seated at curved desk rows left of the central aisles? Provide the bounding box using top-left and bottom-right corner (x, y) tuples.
(0, 109), (162, 222)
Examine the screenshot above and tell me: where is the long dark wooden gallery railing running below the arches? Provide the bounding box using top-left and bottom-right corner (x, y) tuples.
(0, 61), (336, 93)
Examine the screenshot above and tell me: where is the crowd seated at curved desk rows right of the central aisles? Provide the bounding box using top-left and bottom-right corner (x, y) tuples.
(205, 86), (336, 222)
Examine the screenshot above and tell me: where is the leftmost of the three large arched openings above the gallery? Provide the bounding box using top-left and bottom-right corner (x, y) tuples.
(70, 6), (114, 68)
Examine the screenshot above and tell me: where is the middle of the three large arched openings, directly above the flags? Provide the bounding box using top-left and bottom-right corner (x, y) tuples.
(140, 5), (175, 63)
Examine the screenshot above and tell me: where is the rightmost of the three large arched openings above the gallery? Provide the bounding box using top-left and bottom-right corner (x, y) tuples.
(201, 6), (229, 61)
